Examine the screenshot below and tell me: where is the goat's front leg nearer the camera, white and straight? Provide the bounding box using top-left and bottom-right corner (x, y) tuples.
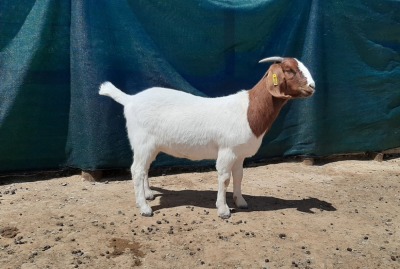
(216, 150), (235, 219)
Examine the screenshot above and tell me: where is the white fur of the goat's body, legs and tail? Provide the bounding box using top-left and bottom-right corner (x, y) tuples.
(99, 82), (263, 218)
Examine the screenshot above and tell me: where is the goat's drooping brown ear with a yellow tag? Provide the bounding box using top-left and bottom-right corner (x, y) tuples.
(266, 64), (292, 99)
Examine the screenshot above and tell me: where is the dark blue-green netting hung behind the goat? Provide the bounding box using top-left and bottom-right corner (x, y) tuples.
(0, 0), (400, 171)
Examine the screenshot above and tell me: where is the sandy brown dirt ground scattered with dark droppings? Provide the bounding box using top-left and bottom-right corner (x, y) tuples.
(0, 158), (400, 269)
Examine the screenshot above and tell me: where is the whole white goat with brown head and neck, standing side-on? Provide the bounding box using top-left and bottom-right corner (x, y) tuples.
(99, 57), (315, 219)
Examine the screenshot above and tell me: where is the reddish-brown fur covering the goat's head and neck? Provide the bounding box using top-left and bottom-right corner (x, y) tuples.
(247, 58), (308, 137)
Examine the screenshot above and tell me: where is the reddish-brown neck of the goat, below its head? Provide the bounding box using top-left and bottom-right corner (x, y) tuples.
(247, 75), (287, 137)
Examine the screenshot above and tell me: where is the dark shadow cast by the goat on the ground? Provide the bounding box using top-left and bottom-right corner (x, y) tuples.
(152, 187), (336, 214)
